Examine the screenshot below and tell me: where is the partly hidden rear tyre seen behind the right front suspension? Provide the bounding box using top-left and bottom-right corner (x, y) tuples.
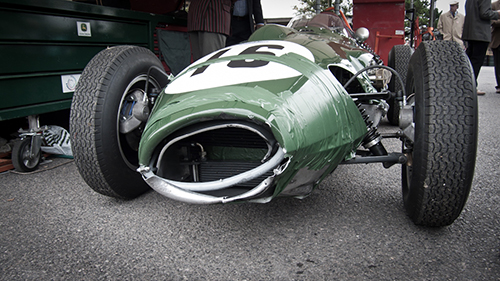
(387, 45), (413, 125)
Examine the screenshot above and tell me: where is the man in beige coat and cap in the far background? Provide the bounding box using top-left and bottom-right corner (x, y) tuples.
(436, 1), (465, 49)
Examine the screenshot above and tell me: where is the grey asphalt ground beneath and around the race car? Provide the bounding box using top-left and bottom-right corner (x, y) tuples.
(0, 67), (500, 280)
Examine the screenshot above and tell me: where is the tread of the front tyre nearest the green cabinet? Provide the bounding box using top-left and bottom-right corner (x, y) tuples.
(70, 46), (158, 198)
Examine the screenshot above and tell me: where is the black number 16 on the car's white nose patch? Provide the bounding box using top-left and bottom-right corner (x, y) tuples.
(191, 45), (285, 77)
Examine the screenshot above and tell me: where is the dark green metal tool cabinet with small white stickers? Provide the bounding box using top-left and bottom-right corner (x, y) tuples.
(0, 0), (186, 121)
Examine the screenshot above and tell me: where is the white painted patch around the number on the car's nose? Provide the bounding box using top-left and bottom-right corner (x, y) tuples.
(165, 41), (314, 94)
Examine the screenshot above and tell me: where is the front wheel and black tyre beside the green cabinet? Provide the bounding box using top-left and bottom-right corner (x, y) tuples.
(70, 46), (168, 198)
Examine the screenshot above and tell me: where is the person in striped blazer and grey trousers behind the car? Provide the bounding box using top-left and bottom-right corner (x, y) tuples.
(188, 0), (235, 61)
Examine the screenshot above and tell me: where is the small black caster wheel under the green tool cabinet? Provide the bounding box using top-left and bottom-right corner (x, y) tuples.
(12, 137), (42, 172)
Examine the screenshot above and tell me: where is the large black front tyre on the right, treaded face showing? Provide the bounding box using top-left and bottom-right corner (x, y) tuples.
(402, 41), (478, 226)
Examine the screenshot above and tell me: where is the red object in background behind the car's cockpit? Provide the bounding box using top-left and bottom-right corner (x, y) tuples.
(352, 0), (405, 64)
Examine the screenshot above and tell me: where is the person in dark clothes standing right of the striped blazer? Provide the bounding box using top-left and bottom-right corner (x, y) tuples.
(226, 0), (264, 46)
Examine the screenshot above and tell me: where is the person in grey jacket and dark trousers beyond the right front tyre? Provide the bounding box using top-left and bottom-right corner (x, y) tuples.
(462, 0), (500, 95)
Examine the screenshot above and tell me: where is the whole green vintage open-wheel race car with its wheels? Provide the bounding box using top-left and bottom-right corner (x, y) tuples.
(70, 13), (478, 226)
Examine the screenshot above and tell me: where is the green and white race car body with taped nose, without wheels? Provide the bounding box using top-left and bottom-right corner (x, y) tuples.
(138, 19), (376, 204)
